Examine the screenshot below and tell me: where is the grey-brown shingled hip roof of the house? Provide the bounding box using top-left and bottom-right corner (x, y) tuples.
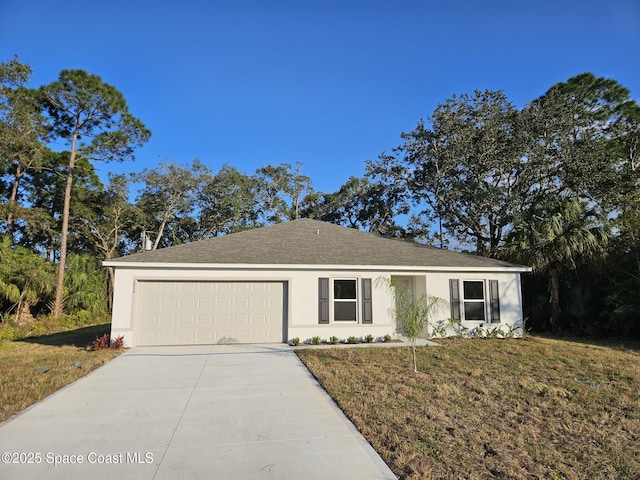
(105, 219), (522, 269)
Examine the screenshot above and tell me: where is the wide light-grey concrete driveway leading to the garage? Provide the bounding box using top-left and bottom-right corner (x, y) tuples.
(0, 345), (396, 480)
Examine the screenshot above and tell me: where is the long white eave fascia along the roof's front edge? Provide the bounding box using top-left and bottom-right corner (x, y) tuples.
(102, 261), (531, 273)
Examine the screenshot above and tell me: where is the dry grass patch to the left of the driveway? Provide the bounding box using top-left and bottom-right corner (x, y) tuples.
(0, 325), (119, 422)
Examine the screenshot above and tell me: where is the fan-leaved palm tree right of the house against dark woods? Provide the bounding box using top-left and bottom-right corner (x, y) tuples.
(507, 197), (608, 332)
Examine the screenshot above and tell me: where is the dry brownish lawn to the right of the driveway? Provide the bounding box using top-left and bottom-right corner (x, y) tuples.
(297, 337), (640, 480)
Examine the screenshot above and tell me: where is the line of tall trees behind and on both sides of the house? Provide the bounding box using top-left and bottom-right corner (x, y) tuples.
(0, 58), (640, 336)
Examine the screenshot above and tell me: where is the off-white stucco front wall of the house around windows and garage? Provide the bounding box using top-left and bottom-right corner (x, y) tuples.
(111, 267), (522, 346)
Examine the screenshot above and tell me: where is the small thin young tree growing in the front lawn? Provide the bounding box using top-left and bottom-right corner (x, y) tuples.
(389, 279), (447, 373)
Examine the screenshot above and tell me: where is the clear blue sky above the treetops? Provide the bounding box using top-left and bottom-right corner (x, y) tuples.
(0, 0), (640, 191)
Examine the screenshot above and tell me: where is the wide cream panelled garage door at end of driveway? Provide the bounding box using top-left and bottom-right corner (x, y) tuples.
(134, 281), (285, 345)
